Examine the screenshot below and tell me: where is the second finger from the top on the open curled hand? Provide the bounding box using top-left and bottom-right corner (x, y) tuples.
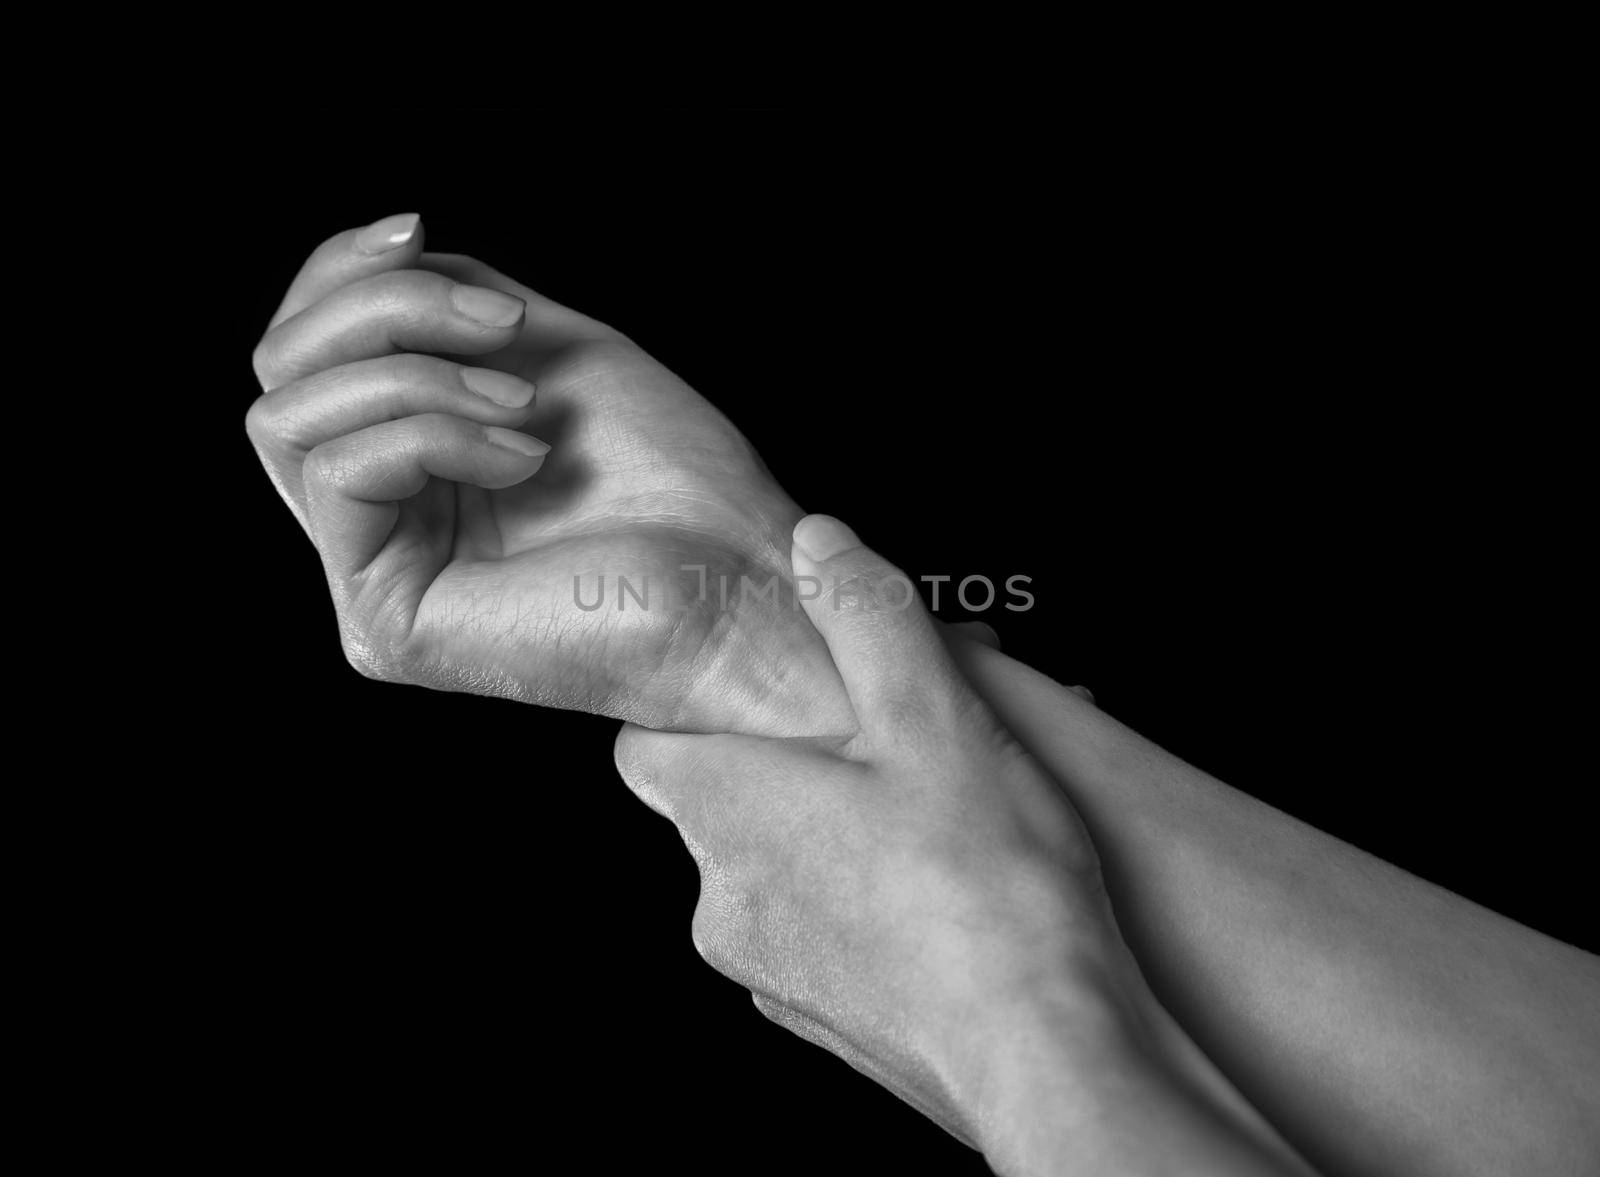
(253, 270), (526, 389)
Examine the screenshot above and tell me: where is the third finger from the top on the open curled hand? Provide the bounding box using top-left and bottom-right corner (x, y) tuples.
(245, 355), (534, 513)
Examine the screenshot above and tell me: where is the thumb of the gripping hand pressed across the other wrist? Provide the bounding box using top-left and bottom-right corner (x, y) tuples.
(792, 515), (962, 745)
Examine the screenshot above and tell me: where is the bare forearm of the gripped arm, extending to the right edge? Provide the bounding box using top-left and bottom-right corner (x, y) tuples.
(957, 643), (1600, 1175)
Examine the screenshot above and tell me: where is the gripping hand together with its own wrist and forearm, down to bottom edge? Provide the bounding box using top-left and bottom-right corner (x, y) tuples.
(616, 515), (1309, 1174)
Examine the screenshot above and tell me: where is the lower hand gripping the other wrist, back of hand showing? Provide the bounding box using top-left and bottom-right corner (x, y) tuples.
(616, 515), (1130, 1140)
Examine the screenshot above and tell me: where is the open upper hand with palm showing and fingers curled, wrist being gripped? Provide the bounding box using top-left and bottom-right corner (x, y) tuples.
(246, 216), (850, 734)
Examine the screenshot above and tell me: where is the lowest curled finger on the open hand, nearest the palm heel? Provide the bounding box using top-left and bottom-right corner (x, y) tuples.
(304, 413), (550, 577)
